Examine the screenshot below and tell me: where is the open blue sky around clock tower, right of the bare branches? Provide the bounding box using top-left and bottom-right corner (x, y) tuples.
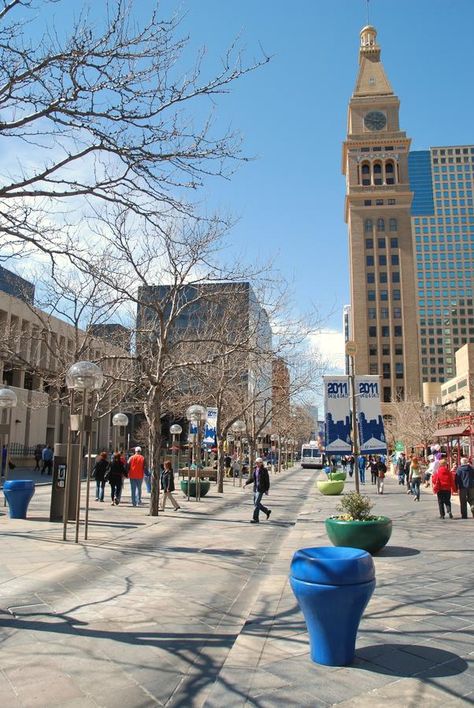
(4, 0), (474, 368)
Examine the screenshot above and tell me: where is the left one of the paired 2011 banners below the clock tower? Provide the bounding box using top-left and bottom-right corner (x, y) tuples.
(323, 376), (352, 455)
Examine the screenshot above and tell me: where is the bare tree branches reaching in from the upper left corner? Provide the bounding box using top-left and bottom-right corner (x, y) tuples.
(0, 0), (268, 259)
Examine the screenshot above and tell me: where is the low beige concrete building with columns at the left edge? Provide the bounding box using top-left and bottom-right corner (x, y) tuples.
(0, 278), (131, 459)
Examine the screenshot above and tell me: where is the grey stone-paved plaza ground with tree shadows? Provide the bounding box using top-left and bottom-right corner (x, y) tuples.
(0, 470), (474, 708)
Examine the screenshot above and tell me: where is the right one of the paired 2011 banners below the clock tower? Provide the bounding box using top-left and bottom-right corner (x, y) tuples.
(355, 376), (387, 455)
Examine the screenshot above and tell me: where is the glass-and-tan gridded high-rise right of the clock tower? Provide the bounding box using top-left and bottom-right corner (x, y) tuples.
(408, 145), (474, 387)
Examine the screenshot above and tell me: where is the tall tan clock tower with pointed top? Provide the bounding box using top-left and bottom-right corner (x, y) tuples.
(343, 26), (421, 406)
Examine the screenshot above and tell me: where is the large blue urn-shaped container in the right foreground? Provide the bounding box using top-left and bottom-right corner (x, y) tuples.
(290, 546), (375, 666)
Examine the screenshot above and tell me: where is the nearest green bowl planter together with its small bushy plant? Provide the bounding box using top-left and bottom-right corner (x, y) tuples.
(325, 492), (392, 553)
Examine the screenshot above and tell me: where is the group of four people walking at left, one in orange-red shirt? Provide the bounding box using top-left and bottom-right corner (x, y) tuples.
(92, 447), (180, 511)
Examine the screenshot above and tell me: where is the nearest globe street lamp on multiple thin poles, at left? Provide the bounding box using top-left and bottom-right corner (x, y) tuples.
(63, 361), (104, 543)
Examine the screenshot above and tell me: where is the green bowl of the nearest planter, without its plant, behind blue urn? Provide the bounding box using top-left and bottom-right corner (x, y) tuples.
(325, 516), (392, 553)
